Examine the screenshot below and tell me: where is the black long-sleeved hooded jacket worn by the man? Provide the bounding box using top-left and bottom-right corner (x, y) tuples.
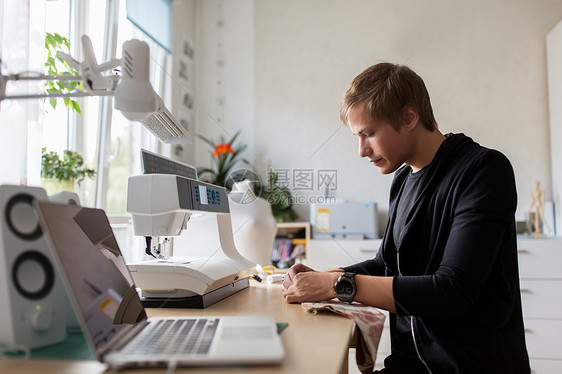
(345, 134), (530, 374)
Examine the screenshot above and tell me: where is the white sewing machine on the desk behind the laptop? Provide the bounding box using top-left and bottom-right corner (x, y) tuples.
(127, 154), (255, 308)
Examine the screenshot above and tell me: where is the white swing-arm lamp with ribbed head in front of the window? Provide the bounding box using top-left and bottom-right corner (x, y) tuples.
(0, 35), (192, 144)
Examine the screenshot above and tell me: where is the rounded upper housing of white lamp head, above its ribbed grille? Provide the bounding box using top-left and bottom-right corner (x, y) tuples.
(115, 39), (158, 121)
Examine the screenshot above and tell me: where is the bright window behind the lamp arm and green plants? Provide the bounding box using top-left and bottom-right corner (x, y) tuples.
(0, 0), (171, 261)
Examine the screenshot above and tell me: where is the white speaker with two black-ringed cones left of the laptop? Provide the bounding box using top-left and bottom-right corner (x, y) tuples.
(0, 185), (66, 349)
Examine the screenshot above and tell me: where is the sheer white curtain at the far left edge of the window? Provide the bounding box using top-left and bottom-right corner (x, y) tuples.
(0, 0), (45, 185)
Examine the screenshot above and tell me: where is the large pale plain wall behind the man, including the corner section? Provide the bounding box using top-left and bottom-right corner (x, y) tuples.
(186, 0), (562, 219)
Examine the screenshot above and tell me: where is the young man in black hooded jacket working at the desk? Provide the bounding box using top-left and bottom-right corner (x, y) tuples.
(283, 63), (530, 374)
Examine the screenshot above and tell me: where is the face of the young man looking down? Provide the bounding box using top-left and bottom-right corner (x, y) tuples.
(349, 105), (412, 174)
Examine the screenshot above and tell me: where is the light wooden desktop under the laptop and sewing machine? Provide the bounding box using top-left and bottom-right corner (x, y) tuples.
(0, 280), (353, 374)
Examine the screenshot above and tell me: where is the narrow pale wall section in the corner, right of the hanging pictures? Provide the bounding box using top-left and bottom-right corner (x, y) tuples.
(194, 0), (254, 167)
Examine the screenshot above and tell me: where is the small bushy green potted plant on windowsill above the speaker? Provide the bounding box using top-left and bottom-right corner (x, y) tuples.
(41, 148), (96, 195)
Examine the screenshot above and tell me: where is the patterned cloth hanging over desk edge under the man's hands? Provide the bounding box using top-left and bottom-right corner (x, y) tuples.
(302, 300), (386, 374)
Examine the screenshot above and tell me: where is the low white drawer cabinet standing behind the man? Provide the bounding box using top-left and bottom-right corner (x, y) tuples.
(307, 236), (562, 374)
